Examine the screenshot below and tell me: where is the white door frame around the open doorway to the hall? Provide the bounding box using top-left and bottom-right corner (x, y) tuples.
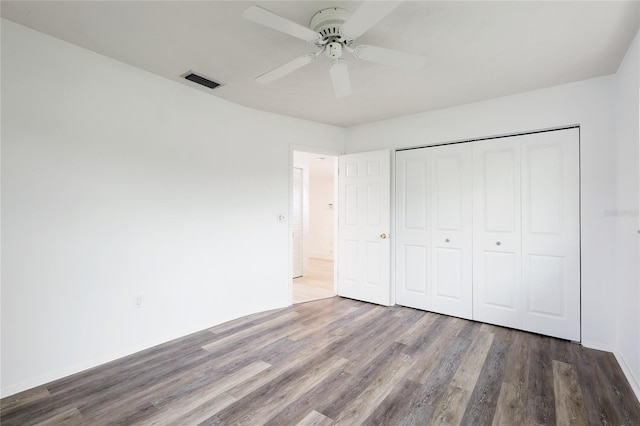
(287, 144), (344, 306)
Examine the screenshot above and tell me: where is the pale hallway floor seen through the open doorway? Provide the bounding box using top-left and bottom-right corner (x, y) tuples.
(293, 258), (336, 303)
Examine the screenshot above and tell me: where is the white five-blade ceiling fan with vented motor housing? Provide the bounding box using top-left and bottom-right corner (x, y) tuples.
(242, 1), (426, 98)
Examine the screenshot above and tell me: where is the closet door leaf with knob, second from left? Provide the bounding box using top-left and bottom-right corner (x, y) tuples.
(428, 144), (473, 318)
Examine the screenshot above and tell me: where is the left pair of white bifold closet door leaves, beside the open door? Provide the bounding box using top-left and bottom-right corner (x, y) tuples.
(396, 144), (473, 318)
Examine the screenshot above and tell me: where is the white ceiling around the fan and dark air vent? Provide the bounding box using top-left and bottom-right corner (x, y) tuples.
(1, 0), (640, 127)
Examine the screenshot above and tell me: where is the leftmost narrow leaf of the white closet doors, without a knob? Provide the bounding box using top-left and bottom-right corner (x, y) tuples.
(395, 149), (431, 310)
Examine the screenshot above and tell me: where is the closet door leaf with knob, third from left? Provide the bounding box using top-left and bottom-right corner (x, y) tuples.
(473, 138), (522, 328)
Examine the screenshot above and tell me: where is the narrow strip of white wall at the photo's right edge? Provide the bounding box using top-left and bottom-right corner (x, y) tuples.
(609, 33), (640, 398)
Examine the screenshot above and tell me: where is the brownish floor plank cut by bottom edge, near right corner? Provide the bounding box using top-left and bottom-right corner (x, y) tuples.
(553, 360), (587, 425)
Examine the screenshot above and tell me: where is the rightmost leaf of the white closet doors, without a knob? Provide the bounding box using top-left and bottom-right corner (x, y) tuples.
(520, 129), (580, 341)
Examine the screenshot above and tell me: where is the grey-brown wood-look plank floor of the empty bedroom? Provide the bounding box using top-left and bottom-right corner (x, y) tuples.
(1, 297), (640, 426)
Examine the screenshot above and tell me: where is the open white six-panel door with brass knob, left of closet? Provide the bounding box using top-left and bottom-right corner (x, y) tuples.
(338, 150), (391, 305)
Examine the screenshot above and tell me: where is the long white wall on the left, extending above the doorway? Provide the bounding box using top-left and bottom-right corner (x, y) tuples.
(1, 20), (344, 396)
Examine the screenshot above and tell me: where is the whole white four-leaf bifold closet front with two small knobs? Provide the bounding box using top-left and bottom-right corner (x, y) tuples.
(395, 128), (580, 341)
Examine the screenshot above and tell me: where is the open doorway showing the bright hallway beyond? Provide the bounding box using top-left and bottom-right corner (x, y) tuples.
(291, 151), (337, 303)
